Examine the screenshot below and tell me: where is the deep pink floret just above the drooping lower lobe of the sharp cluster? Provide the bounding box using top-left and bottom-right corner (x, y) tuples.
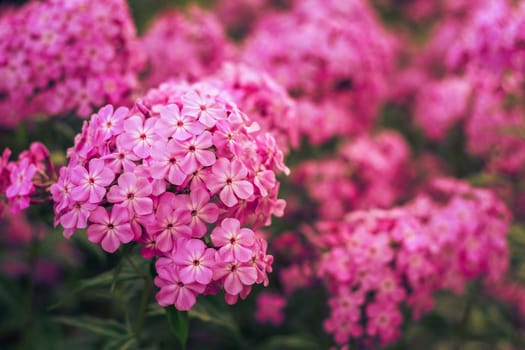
(175, 188), (219, 238)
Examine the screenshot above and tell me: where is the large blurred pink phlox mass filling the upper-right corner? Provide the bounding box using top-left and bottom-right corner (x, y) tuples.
(393, 0), (525, 177)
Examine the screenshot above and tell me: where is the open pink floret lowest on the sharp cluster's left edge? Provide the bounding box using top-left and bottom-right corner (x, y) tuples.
(87, 206), (134, 253)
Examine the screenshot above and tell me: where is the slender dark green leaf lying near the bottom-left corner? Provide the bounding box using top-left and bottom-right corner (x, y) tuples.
(52, 316), (129, 338)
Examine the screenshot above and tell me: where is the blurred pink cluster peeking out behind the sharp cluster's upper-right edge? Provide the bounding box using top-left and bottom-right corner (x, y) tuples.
(211, 63), (299, 152)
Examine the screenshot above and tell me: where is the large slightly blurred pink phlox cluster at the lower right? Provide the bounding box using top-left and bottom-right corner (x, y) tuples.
(315, 178), (510, 344)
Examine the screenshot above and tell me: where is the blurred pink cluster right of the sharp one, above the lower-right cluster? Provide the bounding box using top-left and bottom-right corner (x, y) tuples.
(293, 131), (410, 219)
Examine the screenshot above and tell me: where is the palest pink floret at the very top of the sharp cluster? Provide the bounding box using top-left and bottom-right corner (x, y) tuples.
(182, 91), (226, 128)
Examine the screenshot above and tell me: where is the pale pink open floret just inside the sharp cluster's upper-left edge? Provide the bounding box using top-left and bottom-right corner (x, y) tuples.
(119, 115), (159, 158)
